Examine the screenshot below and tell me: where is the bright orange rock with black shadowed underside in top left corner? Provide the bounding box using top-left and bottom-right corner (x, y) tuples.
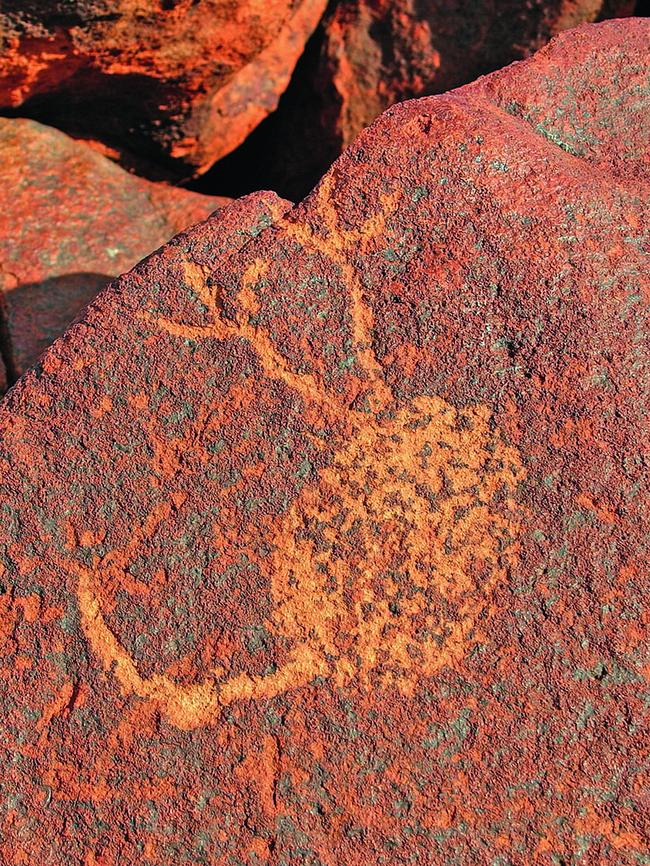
(0, 0), (326, 175)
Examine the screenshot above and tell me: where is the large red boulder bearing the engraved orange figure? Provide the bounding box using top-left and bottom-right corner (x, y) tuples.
(0, 20), (650, 866)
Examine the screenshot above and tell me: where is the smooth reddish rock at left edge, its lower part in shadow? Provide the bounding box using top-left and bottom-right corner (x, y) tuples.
(0, 118), (229, 385)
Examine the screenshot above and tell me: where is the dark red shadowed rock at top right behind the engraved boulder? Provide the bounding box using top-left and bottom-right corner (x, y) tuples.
(320, 0), (634, 152)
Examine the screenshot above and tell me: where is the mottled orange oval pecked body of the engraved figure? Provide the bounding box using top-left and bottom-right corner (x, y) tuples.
(271, 398), (523, 691)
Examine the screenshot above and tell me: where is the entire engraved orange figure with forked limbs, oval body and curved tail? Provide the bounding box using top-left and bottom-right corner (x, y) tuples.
(68, 189), (524, 729)
